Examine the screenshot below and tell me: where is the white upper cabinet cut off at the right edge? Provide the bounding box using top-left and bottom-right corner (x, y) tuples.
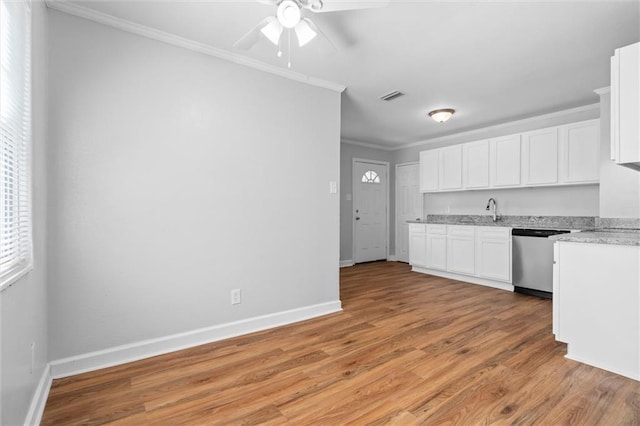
(611, 43), (640, 171)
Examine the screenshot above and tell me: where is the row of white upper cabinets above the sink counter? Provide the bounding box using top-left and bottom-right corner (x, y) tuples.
(420, 117), (600, 192)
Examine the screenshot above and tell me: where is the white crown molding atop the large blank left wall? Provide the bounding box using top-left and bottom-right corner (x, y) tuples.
(45, 0), (346, 93)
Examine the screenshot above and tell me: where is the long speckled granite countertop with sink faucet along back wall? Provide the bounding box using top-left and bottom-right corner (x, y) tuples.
(408, 214), (596, 230)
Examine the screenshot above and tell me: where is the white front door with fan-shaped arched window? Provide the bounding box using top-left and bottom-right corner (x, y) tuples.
(353, 160), (388, 263)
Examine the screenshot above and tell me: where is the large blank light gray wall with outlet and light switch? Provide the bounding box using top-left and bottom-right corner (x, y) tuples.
(49, 12), (340, 360)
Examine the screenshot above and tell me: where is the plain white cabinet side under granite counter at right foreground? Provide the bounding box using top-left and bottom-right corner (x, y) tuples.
(553, 241), (640, 380)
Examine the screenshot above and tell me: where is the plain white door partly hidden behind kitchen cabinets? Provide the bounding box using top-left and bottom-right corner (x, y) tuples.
(396, 163), (423, 262)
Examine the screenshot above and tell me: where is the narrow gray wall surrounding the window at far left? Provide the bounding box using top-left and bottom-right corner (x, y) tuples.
(0, 2), (48, 425)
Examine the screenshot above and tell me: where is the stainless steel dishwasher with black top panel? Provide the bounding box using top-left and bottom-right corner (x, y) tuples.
(511, 228), (571, 299)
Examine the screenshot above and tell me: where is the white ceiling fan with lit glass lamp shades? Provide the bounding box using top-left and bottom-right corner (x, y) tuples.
(233, 0), (389, 68)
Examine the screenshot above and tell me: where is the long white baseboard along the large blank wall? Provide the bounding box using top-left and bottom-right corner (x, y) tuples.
(51, 300), (342, 379)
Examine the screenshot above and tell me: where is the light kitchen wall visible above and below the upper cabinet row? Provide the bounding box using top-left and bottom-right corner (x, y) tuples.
(394, 104), (599, 216)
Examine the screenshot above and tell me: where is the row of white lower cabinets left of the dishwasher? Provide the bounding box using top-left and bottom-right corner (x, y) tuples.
(409, 223), (513, 290)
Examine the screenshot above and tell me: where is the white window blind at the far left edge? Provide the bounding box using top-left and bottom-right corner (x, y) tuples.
(0, 0), (33, 290)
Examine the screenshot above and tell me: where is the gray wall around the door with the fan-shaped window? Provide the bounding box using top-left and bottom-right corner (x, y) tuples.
(340, 142), (395, 261)
